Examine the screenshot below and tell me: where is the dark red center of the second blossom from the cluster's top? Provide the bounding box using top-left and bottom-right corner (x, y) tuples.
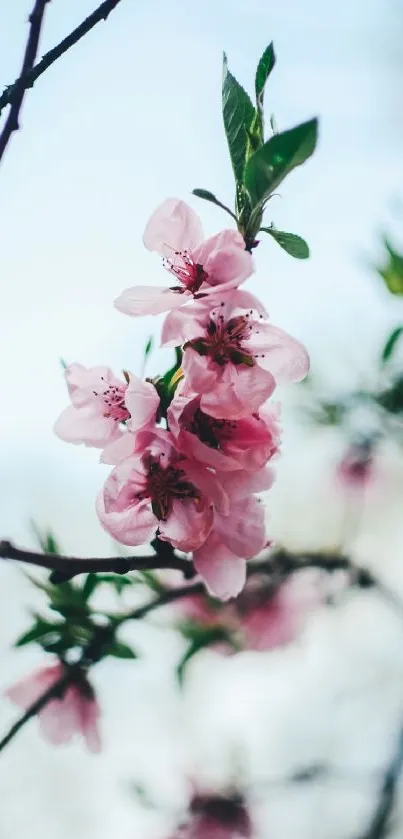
(185, 312), (255, 367)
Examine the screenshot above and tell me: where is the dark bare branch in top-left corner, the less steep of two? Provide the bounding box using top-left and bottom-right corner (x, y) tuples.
(0, 0), (124, 121)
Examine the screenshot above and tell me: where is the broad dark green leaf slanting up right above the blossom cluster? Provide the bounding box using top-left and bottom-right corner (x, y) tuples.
(245, 119), (318, 207)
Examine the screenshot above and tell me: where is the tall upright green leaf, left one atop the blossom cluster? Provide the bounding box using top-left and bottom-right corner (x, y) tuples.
(222, 53), (256, 183)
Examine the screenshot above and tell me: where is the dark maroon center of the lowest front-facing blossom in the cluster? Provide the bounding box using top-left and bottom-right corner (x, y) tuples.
(138, 455), (199, 521)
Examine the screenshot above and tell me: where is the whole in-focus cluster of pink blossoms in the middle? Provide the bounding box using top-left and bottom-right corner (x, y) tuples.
(55, 198), (309, 600)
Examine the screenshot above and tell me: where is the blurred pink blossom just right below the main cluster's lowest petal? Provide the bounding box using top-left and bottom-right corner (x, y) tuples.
(239, 571), (323, 650)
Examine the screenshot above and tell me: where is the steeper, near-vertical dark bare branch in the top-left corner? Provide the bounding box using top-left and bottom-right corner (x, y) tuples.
(0, 0), (50, 160)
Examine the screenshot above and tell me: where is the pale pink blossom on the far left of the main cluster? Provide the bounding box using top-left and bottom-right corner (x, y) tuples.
(54, 364), (159, 463)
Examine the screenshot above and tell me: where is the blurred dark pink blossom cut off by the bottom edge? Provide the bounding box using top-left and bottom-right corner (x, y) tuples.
(170, 794), (252, 839)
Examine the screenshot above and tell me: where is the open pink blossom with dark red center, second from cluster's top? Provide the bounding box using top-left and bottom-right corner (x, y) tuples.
(163, 289), (309, 420)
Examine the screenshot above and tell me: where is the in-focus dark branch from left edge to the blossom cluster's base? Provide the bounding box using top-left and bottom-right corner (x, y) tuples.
(0, 541), (194, 583)
